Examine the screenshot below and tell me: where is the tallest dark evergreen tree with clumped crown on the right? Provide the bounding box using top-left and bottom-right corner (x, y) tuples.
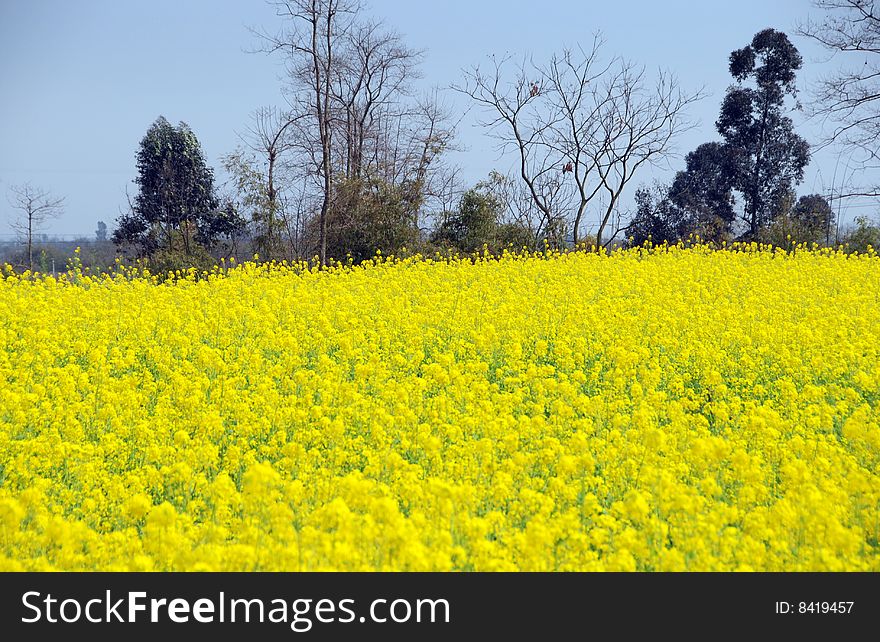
(716, 29), (810, 236)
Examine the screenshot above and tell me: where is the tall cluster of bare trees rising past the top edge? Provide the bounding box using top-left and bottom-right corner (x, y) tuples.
(258, 0), (454, 263)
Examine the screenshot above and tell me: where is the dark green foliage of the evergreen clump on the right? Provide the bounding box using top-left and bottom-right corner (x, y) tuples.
(652, 29), (812, 245)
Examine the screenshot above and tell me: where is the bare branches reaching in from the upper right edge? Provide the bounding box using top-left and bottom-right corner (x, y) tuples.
(798, 0), (880, 197)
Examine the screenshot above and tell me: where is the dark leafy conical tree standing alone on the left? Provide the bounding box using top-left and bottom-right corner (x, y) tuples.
(113, 116), (240, 256)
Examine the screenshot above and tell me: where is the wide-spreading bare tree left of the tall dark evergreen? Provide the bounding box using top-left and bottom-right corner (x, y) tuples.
(456, 35), (703, 247)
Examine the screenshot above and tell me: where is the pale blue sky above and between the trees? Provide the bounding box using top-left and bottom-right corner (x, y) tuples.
(0, 0), (873, 238)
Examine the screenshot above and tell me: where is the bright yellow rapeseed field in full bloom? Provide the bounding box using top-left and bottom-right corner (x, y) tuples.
(0, 247), (880, 571)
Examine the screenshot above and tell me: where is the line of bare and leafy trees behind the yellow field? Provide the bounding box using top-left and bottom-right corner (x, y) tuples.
(5, 0), (880, 269)
